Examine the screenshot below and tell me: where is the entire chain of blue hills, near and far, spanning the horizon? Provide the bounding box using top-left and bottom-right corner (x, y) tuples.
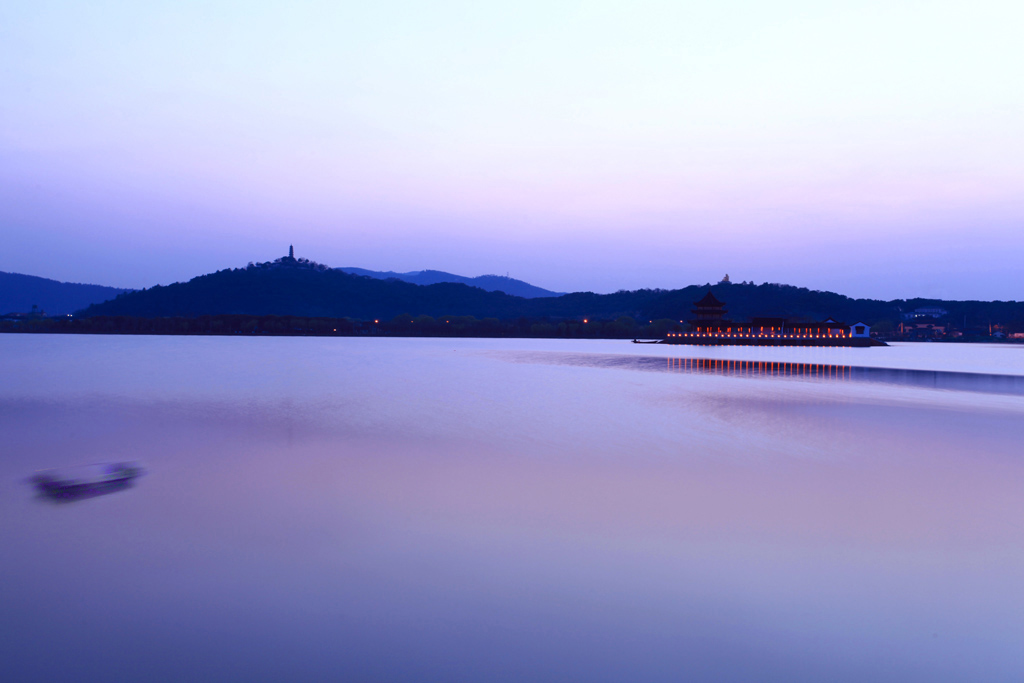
(0, 256), (1024, 329)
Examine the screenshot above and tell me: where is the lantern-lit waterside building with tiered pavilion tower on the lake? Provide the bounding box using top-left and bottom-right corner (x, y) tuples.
(660, 291), (887, 347)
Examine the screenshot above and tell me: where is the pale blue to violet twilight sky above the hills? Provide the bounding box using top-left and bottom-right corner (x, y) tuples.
(0, 0), (1024, 300)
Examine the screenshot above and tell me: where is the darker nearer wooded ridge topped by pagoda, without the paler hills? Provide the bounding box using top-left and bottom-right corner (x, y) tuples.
(81, 262), (1024, 325)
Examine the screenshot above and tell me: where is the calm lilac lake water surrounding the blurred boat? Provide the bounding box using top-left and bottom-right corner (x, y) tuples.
(0, 335), (1024, 681)
